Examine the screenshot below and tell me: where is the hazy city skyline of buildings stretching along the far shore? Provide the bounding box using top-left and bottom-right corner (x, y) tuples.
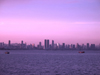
(0, 39), (100, 50)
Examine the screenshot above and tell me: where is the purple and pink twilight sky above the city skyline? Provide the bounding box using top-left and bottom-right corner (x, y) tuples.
(0, 0), (100, 44)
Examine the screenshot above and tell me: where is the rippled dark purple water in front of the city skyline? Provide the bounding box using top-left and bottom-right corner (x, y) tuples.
(0, 50), (100, 75)
